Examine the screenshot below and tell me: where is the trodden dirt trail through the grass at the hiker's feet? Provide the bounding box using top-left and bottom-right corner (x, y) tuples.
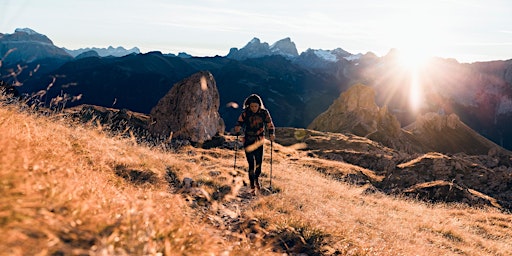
(168, 143), (277, 251)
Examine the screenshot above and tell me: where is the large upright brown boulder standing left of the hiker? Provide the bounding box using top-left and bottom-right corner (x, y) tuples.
(149, 71), (225, 143)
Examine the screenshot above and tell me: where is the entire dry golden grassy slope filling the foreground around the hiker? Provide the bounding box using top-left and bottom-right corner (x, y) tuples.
(0, 106), (512, 255)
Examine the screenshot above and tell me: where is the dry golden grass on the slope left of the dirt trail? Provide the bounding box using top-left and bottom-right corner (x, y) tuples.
(0, 107), (246, 255)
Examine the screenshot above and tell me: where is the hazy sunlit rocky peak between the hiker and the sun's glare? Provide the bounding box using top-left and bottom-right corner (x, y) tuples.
(308, 84), (401, 137)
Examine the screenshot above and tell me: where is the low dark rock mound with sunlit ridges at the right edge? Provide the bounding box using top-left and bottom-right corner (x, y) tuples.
(384, 153), (512, 209)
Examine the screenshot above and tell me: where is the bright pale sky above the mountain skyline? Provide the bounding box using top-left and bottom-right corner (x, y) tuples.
(0, 0), (512, 62)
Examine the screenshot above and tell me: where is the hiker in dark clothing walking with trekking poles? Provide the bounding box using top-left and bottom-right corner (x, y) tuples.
(234, 94), (275, 195)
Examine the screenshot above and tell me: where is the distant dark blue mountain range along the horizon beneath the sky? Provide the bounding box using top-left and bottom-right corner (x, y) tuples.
(0, 29), (512, 149)
